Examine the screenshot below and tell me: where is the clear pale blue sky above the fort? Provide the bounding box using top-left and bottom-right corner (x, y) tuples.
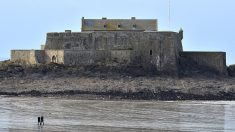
(0, 0), (235, 65)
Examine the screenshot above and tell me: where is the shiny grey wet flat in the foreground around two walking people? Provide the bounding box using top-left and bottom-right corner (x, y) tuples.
(0, 97), (235, 132)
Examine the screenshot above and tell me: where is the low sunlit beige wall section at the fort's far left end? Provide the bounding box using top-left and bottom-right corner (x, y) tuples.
(11, 50), (37, 64)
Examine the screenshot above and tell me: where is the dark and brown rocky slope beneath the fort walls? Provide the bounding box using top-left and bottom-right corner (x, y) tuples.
(0, 62), (235, 100)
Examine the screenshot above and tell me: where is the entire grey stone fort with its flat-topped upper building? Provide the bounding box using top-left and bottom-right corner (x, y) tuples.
(11, 17), (227, 74)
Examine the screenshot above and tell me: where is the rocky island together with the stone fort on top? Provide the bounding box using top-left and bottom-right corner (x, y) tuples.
(0, 17), (235, 100)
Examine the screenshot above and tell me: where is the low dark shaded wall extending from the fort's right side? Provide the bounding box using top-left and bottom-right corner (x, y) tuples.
(180, 52), (227, 75)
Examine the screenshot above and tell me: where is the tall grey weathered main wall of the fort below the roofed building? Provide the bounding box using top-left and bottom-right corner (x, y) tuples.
(45, 31), (182, 73)
